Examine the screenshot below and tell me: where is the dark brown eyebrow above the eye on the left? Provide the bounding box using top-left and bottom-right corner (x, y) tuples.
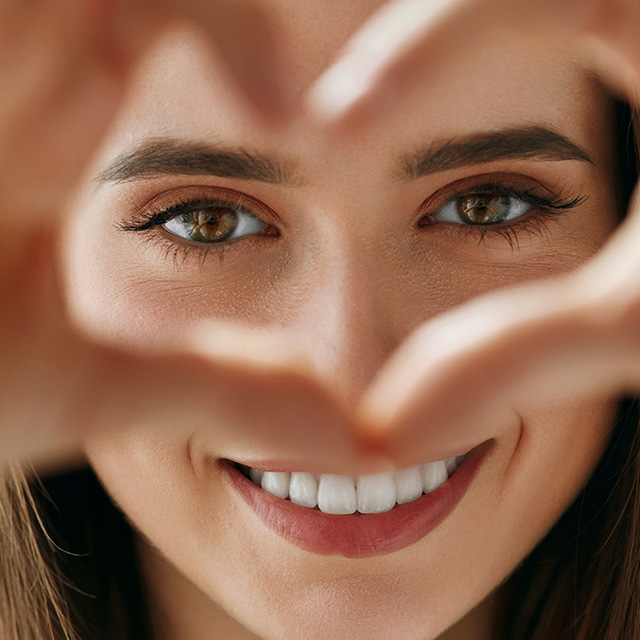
(97, 138), (292, 184)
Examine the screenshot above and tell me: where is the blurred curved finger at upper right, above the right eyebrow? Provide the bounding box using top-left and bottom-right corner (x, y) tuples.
(307, 0), (640, 127)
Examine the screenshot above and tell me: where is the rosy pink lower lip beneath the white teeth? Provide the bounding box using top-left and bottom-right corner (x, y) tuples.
(221, 440), (493, 558)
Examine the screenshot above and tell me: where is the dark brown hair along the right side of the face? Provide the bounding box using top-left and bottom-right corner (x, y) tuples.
(502, 103), (640, 640)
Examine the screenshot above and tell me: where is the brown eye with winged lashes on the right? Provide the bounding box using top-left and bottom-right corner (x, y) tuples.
(418, 172), (586, 244)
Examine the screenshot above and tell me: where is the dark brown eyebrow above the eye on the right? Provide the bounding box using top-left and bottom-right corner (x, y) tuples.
(401, 126), (593, 179)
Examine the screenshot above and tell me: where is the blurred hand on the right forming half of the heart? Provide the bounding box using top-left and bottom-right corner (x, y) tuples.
(302, 0), (640, 466)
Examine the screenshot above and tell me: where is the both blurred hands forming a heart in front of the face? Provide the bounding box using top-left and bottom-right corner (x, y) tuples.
(6, 0), (640, 470)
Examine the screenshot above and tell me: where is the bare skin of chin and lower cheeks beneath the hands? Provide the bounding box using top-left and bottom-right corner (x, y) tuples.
(82, 401), (615, 640)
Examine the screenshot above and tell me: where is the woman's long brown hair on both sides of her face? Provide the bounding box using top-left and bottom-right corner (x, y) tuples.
(0, 105), (640, 640)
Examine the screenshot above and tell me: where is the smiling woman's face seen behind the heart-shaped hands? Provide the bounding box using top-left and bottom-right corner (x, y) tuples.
(63, 0), (618, 640)
